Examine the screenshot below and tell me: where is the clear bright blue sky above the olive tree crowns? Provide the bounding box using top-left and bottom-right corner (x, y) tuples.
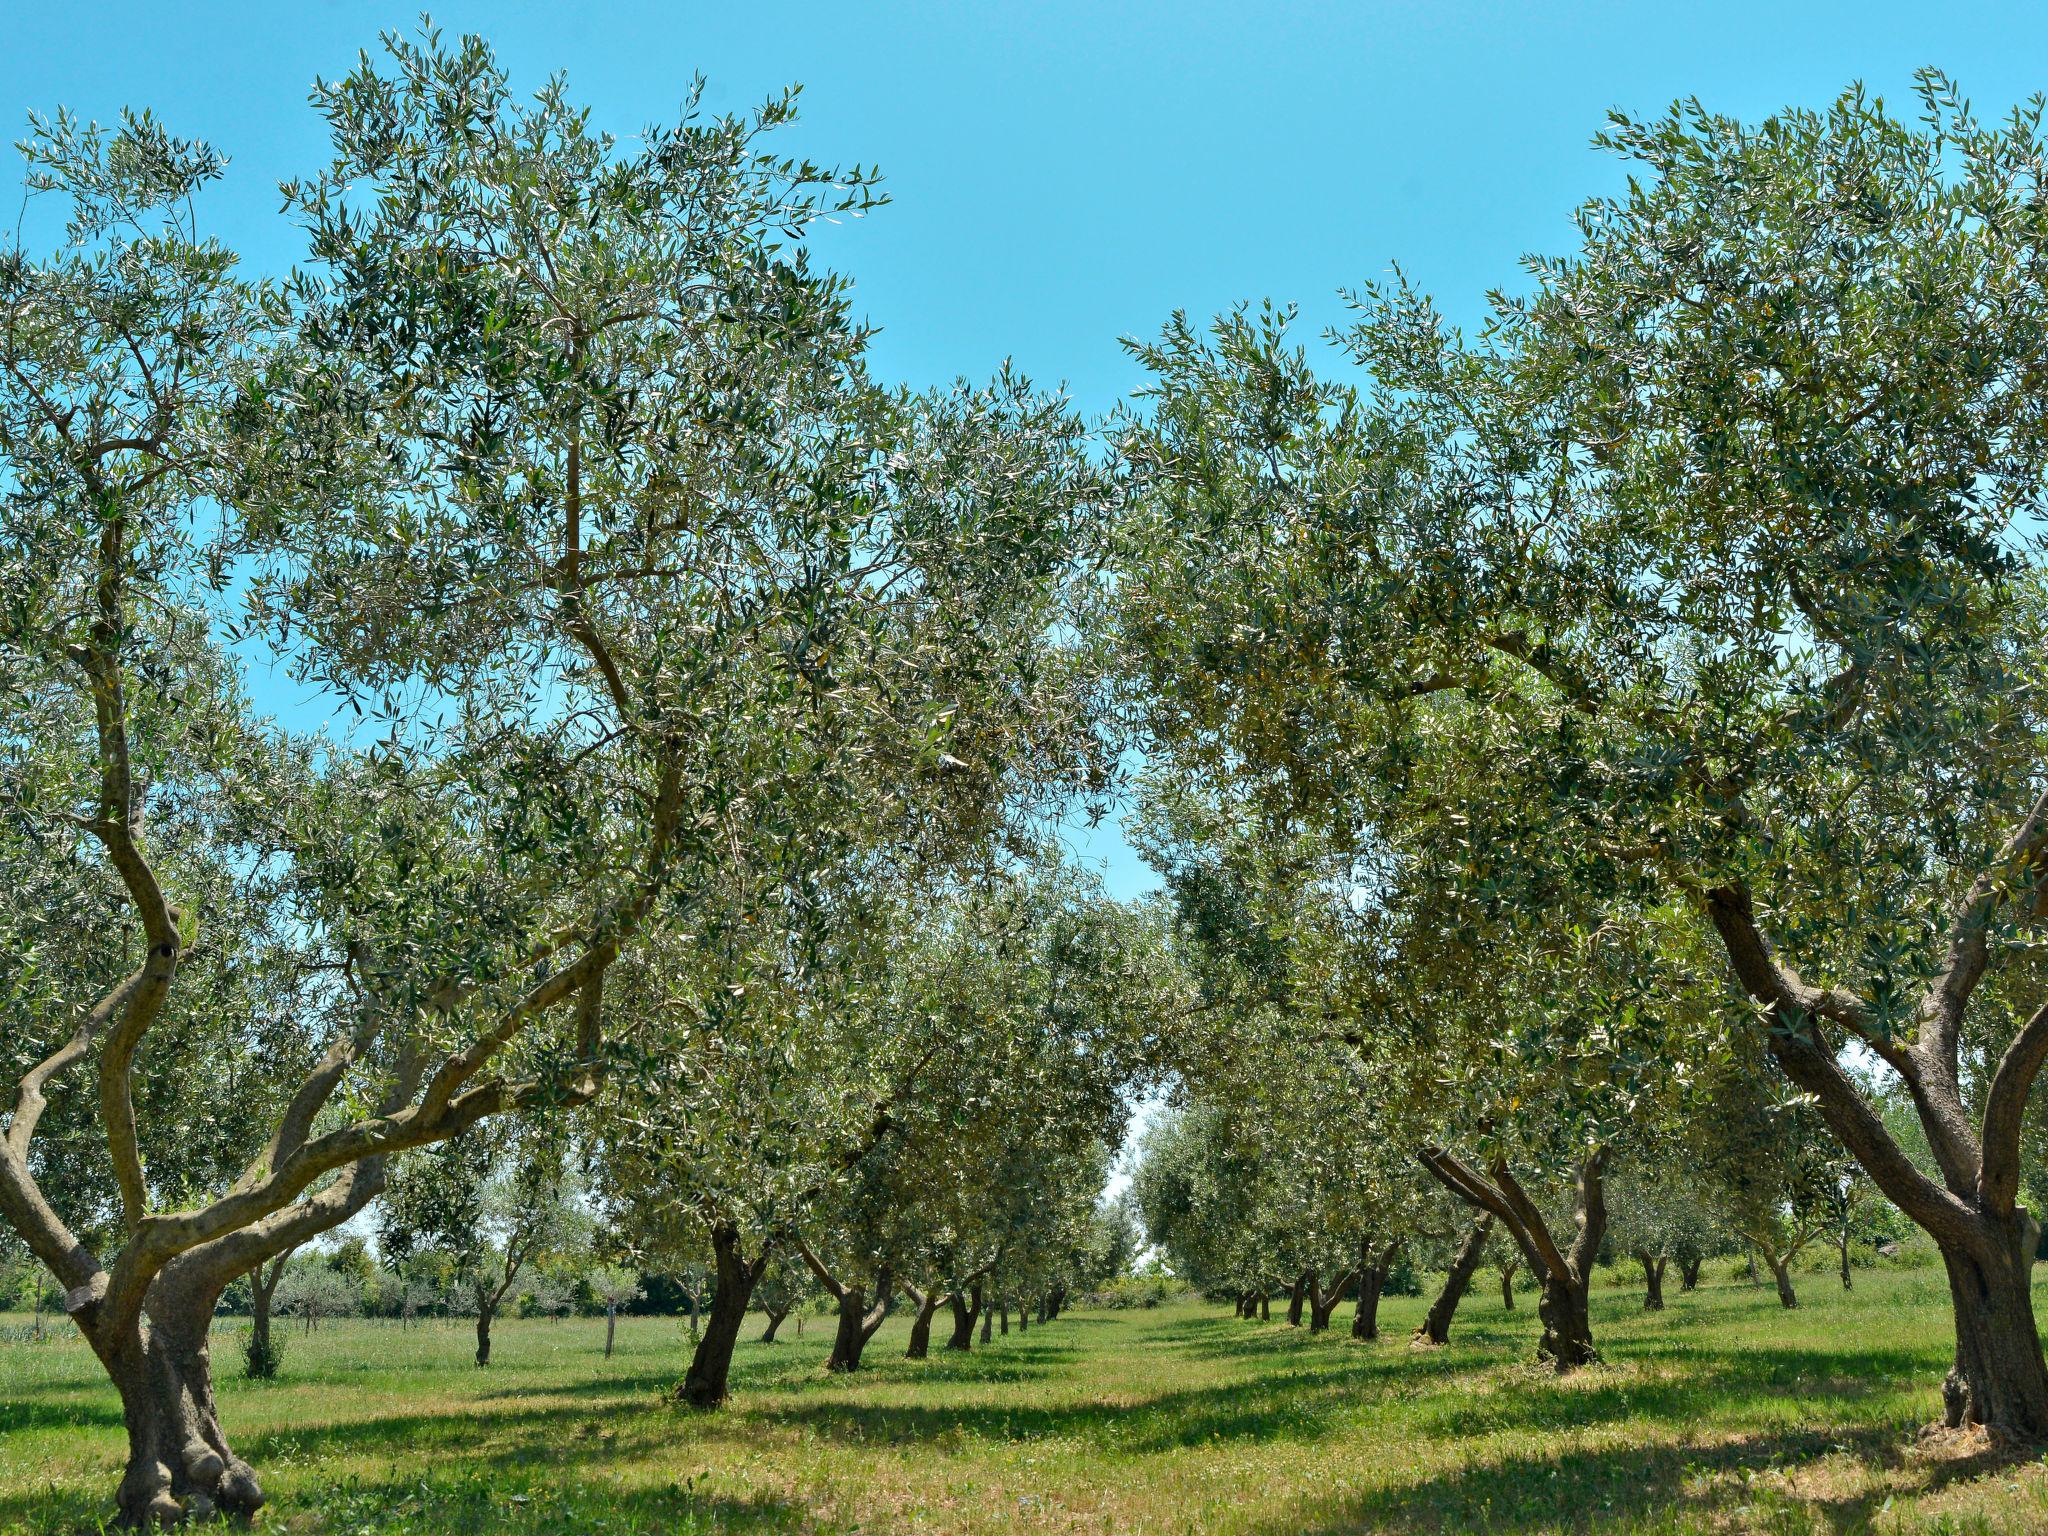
(16, 0), (2048, 893)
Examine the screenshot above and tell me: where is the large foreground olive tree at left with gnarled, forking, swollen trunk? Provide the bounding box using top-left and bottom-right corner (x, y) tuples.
(0, 35), (1116, 1524)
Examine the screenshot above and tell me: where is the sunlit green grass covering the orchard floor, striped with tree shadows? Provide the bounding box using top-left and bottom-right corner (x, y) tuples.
(0, 1272), (2048, 1536)
